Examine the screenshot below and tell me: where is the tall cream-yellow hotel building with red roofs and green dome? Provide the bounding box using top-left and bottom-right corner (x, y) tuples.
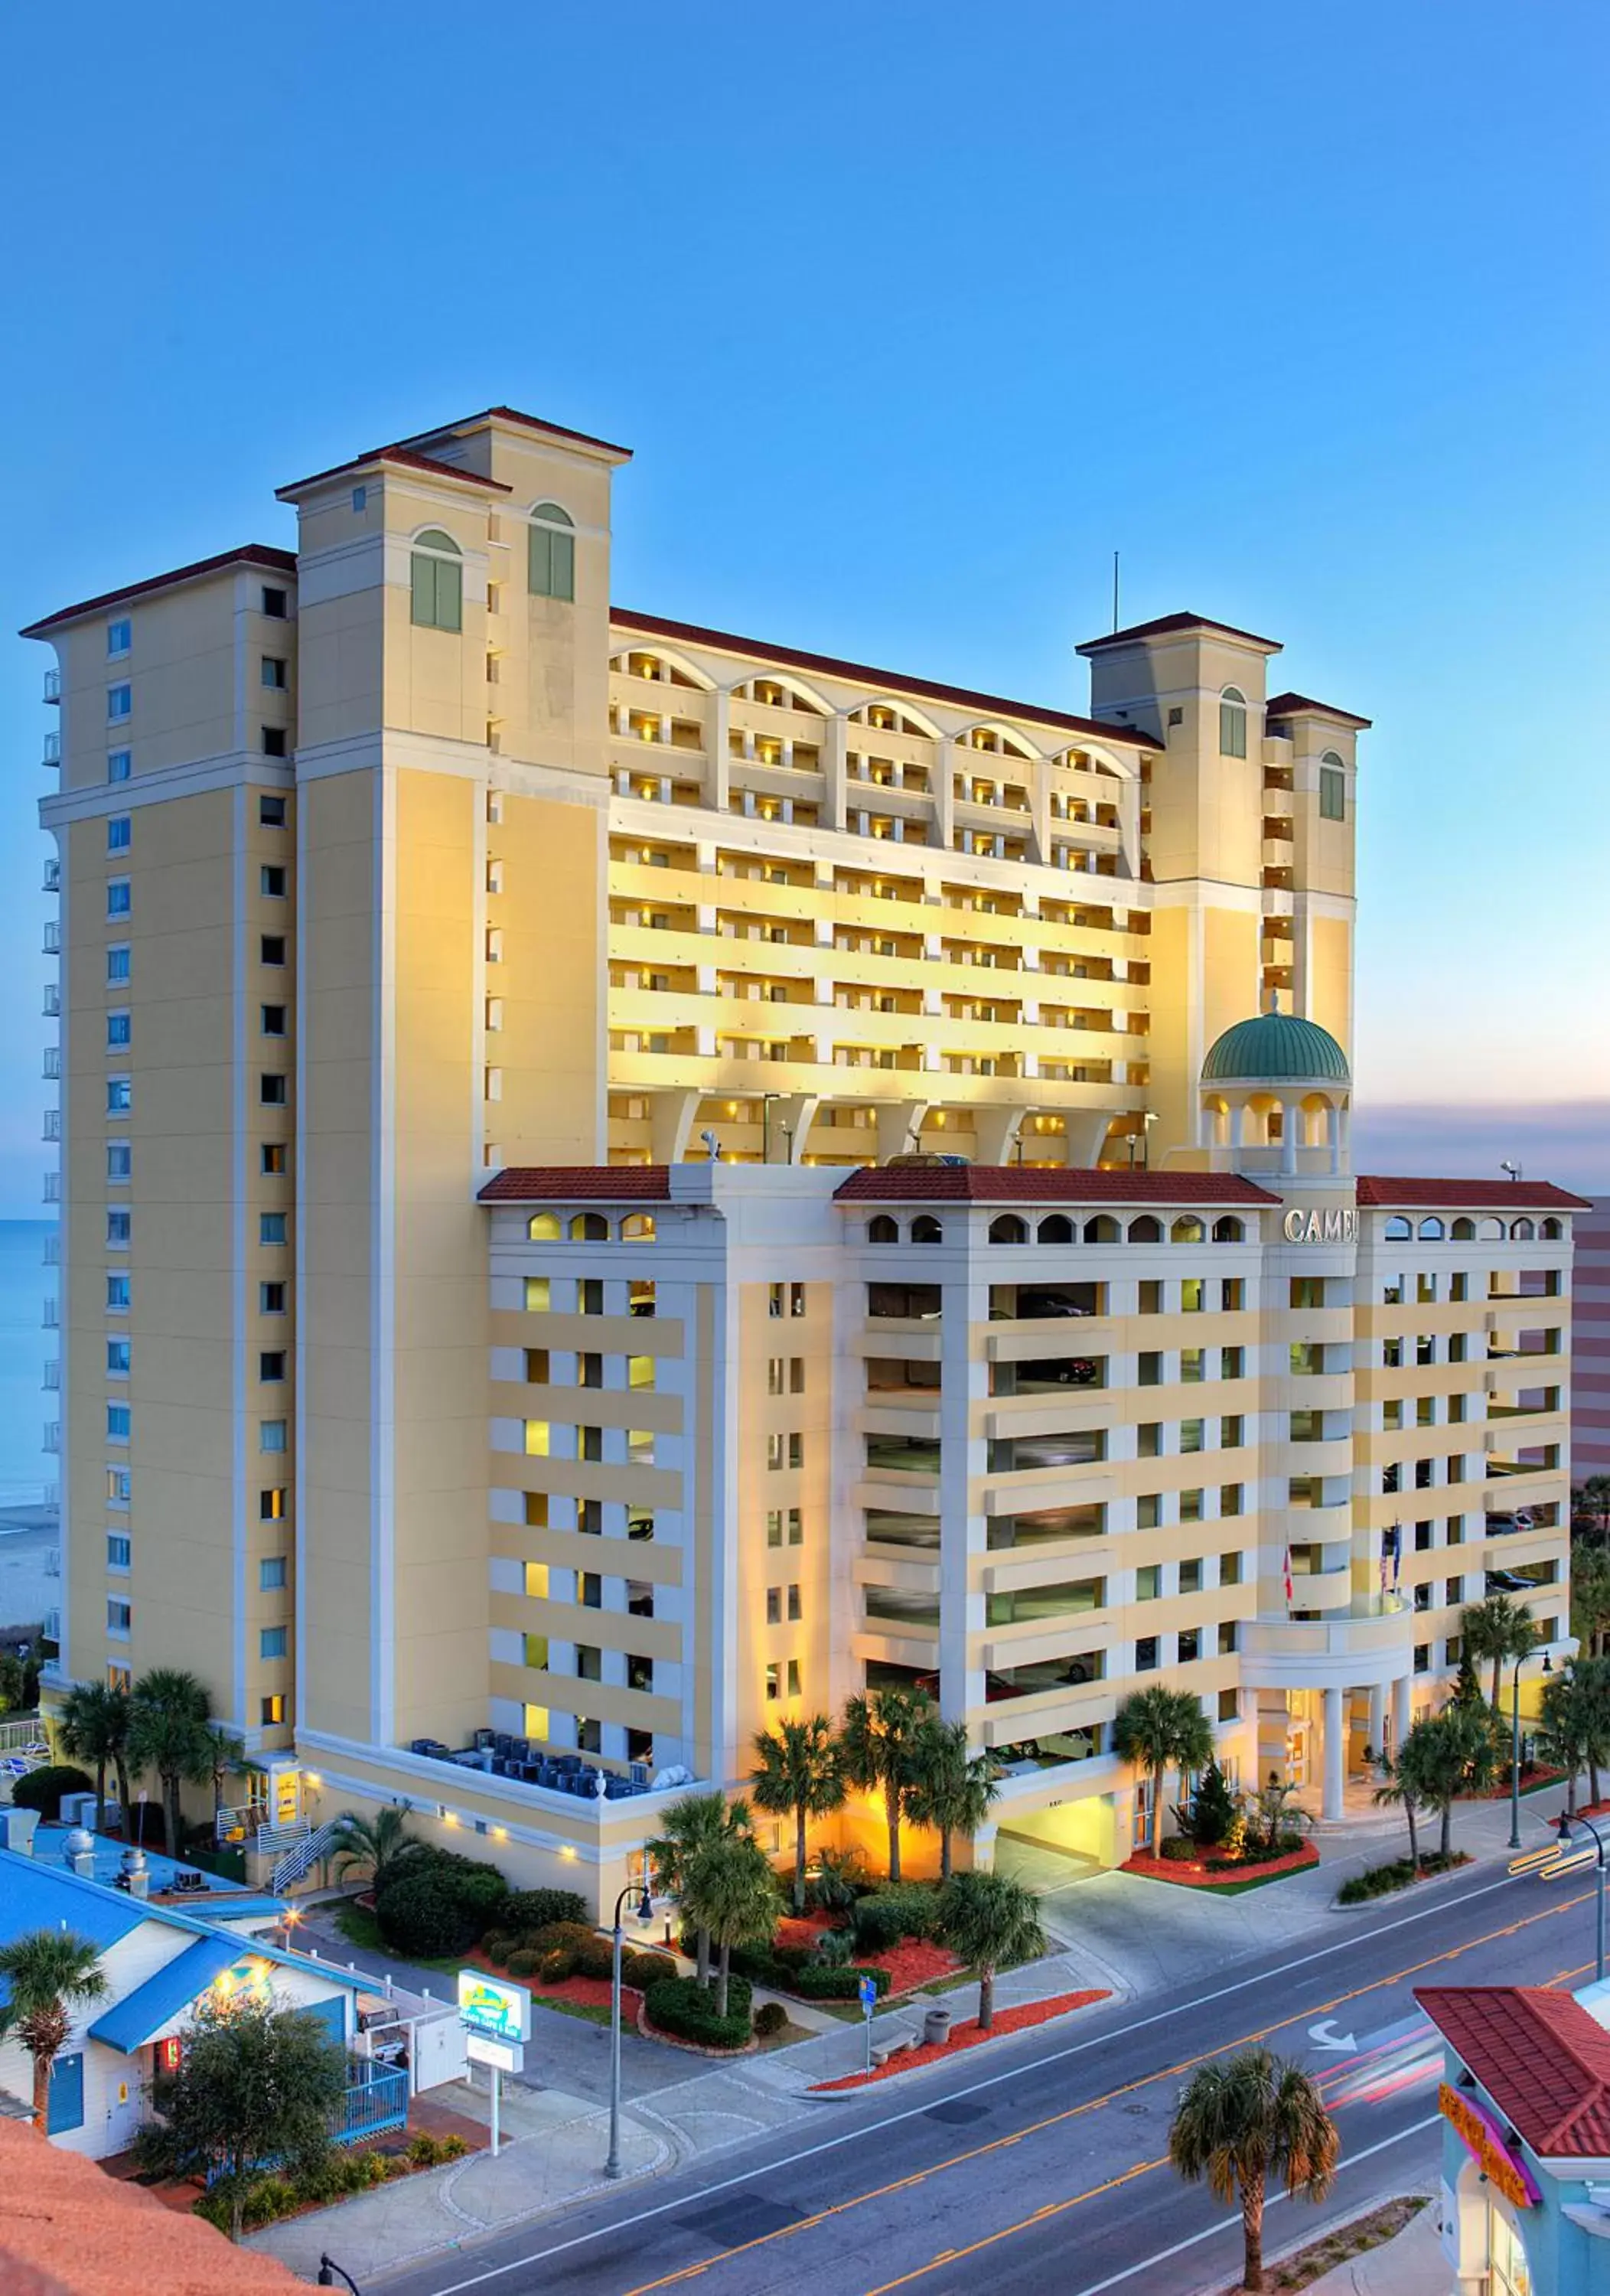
(28, 409), (1576, 1896)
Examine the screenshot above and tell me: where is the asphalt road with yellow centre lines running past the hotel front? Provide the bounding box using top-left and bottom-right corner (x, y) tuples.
(386, 1878), (1592, 2296)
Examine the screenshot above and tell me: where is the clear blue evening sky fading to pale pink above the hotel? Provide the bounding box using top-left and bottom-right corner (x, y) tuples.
(0, 0), (1610, 1217)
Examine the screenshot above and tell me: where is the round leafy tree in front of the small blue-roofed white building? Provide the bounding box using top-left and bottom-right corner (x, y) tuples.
(140, 1998), (347, 2241)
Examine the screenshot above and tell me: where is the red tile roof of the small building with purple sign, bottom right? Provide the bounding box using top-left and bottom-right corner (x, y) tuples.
(1415, 1986), (1610, 2161)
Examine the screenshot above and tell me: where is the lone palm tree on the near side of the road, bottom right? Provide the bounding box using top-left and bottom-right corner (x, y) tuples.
(1169, 2048), (1341, 2291)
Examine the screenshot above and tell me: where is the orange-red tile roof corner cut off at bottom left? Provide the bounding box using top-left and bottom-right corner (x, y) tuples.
(0, 2119), (305, 2296)
